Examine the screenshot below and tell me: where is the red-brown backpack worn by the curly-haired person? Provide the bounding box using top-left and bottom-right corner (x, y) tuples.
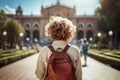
(45, 45), (75, 80)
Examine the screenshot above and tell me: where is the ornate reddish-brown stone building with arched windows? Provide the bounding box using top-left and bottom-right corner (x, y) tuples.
(8, 1), (97, 44)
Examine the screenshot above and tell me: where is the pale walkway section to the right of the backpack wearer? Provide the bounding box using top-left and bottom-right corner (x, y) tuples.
(82, 57), (120, 80)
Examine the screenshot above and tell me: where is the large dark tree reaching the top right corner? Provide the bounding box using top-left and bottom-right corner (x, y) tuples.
(98, 0), (120, 47)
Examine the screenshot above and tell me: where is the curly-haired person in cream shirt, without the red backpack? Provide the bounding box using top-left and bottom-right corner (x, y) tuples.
(36, 16), (82, 80)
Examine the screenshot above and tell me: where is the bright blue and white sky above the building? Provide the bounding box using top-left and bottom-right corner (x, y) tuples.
(0, 0), (100, 15)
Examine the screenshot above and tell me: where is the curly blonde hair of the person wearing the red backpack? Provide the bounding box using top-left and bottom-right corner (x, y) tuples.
(45, 16), (76, 41)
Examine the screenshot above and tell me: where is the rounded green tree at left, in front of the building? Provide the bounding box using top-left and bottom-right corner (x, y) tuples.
(3, 19), (25, 48)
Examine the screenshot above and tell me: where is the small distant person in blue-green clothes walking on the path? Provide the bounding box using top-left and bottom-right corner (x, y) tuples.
(82, 40), (88, 66)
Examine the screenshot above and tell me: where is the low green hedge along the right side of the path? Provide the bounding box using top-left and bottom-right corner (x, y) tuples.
(89, 50), (120, 70)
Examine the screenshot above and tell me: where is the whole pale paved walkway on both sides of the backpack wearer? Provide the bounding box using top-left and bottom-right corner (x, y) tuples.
(0, 54), (120, 80)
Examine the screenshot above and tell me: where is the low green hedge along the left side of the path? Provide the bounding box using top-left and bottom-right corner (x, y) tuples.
(0, 50), (36, 67)
